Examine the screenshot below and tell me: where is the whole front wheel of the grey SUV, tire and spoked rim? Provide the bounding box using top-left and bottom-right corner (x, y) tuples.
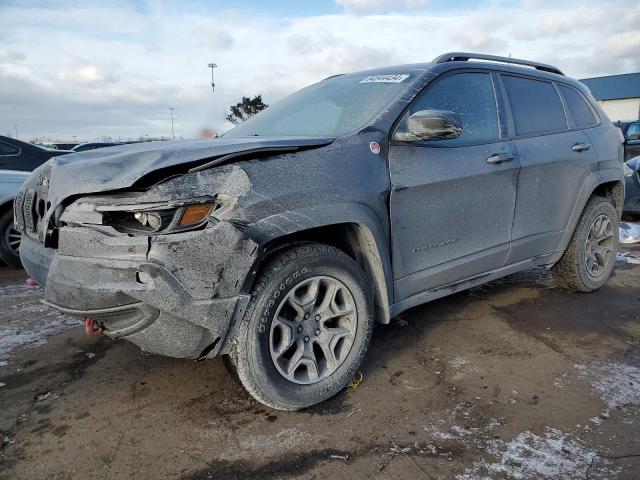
(232, 244), (373, 410)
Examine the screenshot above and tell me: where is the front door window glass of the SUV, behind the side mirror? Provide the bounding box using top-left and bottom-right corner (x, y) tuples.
(397, 72), (499, 146)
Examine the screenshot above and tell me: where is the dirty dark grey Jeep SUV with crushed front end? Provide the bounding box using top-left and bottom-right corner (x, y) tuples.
(15, 53), (624, 410)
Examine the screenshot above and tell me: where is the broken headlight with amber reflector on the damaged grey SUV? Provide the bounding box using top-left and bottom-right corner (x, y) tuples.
(60, 197), (224, 235)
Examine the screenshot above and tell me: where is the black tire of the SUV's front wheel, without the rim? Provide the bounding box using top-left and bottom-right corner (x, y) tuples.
(232, 244), (374, 410)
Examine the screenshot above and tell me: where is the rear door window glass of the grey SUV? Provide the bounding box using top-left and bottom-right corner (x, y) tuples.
(502, 75), (567, 135)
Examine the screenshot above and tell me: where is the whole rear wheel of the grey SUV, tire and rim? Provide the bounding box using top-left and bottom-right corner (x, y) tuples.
(552, 197), (620, 292)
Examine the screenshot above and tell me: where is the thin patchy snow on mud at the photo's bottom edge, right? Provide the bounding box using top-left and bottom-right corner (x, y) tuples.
(456, 427), (618, 480)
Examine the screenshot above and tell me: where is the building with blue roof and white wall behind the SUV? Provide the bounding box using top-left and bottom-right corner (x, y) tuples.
(580, 72), (640, 122)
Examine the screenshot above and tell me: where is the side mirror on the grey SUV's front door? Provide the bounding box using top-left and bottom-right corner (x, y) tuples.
(393, 110), (462, 142)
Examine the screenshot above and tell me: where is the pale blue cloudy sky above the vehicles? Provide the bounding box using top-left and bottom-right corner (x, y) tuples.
(0, 0), (640, 140)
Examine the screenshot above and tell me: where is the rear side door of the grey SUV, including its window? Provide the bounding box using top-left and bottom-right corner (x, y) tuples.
(500, 73), (597, 263)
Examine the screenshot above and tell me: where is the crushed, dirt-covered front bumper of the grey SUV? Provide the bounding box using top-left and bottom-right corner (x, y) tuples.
(20, 221), (258, 358)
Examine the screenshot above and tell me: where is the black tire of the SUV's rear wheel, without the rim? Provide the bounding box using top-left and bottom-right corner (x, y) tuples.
(551, 197), (620, 292)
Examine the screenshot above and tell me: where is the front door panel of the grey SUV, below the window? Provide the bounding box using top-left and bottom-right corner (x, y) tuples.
(389, 142), (519, 300)
